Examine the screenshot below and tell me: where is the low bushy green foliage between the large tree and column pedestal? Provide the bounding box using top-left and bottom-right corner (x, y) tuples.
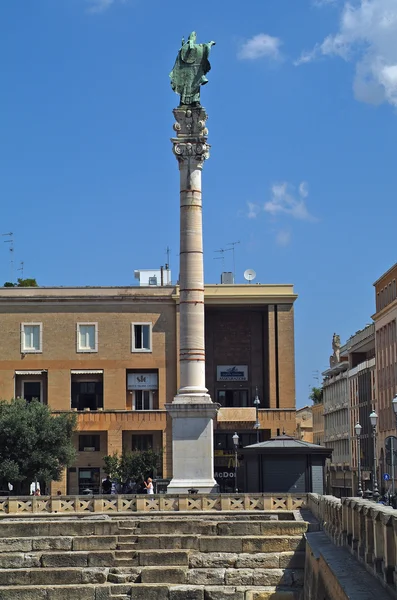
(103, 450), (162, 485)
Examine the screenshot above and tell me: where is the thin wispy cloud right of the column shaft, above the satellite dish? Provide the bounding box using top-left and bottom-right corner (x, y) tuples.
(263, 181), (317, 221)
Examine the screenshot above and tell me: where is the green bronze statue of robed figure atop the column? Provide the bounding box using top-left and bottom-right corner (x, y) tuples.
(170, 31), (215, 106)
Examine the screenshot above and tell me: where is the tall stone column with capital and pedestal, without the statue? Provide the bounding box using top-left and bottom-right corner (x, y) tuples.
(166, 106), (219, 494)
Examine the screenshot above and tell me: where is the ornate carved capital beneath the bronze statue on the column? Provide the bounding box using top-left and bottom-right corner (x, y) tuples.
(171, 106), (210, 167)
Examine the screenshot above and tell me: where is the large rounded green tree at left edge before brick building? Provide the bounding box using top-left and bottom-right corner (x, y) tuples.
(0, 398), (76, 494)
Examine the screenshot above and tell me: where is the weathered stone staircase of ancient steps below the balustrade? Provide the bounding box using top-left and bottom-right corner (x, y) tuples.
(0, 512), (308, 600)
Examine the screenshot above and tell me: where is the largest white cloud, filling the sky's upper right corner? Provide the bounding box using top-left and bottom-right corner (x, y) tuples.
(295, 0), (397, 107)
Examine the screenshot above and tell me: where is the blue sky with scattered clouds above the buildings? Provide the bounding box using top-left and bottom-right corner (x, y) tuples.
(0, 0), (397, 406)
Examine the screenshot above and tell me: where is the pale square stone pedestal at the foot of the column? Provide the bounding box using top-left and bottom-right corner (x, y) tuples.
(165, 394), (219, 494)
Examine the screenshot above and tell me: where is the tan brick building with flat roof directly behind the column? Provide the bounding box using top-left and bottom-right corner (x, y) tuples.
(0, 285), (296, 494)
